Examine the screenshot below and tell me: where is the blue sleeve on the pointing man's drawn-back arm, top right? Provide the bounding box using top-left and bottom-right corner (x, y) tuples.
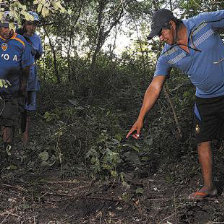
(195, 10), (224, 29)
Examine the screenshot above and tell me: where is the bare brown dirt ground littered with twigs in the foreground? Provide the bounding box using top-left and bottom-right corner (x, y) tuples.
(0, 170), (224, 224)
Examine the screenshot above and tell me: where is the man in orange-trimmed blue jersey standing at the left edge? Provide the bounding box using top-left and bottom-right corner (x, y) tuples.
(0, 12), (34, 159)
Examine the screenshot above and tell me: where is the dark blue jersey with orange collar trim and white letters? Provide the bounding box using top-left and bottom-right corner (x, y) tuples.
(0, 33), (34, 94)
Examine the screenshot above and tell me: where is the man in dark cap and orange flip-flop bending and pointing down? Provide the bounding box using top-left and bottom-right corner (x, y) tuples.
(127, 9), (224, 199)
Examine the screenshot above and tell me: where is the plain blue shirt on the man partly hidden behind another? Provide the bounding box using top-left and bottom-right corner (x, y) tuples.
(26, 33), (43, 91)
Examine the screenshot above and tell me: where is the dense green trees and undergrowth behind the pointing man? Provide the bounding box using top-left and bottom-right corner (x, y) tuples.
(4, 0), (224, 180)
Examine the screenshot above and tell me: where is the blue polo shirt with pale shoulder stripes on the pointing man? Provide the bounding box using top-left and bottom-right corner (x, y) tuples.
(154, 10), (224, 98)
